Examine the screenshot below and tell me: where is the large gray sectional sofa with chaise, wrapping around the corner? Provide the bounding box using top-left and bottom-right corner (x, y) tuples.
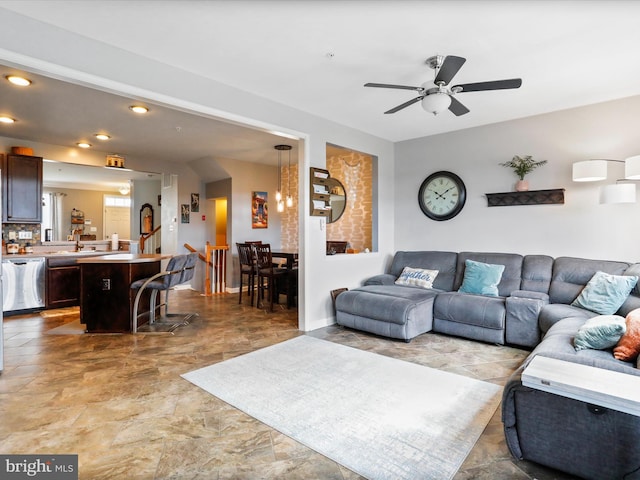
(336, 251), (640, 479)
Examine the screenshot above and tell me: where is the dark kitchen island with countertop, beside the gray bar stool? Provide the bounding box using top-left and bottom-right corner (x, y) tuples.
(77, 253), (165, 333)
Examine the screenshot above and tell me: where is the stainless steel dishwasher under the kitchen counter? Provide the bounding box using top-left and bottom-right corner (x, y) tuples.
(2, 256), (45, 313)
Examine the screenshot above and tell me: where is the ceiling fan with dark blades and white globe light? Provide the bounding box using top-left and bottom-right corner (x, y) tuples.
(364, 55), (522, 117)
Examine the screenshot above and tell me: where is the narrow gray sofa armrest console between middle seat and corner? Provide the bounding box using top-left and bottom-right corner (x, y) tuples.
(505, 290), (549, 347)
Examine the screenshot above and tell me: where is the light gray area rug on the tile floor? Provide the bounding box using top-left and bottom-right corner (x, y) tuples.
(182, 336), (500, 480)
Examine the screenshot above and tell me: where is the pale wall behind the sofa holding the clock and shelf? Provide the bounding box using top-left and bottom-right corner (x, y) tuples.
(395, 97), (640, 262)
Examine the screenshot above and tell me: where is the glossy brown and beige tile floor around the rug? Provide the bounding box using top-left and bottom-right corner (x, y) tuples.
(0, 290), (571, 480)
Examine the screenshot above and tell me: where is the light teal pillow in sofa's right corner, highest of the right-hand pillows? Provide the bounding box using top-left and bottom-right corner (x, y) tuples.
(571, 272), (638, 315)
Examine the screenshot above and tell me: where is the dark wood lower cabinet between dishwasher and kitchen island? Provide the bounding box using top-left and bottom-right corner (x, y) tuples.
(46, 259), (80, 308)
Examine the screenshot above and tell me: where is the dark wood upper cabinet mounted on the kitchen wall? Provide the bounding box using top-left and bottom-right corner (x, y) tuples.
(2, 154), (42, 223)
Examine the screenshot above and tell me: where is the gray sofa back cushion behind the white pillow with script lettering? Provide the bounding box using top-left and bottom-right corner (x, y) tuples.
(388, 251), (458, 292)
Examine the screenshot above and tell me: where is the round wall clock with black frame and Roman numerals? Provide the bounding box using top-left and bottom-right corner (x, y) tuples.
(418, 171), (467, 221)
